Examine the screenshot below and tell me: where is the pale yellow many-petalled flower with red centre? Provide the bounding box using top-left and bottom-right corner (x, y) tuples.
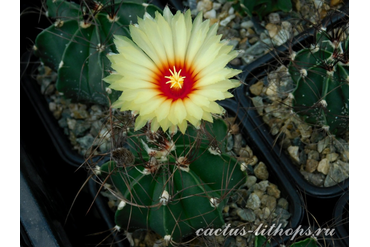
(104, 7), (241, 133)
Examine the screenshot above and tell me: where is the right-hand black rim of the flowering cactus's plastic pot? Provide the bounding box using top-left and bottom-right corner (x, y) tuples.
(219, 99), (304, 247)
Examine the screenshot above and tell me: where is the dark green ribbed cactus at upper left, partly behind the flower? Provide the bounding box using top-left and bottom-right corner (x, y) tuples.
(34, 0), (160, 105)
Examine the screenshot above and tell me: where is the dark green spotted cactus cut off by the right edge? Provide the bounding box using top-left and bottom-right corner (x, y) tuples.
(289, 26), (349, 135)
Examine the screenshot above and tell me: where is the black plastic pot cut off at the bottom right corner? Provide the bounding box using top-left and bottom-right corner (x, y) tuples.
(334, 191), (349, 247)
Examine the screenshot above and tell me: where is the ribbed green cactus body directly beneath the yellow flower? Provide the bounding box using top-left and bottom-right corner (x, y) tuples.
(100, 120), (246, 242)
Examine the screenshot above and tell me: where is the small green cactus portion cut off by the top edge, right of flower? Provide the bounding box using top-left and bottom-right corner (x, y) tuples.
(229, 0), (292, 20)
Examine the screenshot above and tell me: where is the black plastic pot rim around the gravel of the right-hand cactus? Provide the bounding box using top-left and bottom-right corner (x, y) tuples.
(235, 7), (349, 198)
